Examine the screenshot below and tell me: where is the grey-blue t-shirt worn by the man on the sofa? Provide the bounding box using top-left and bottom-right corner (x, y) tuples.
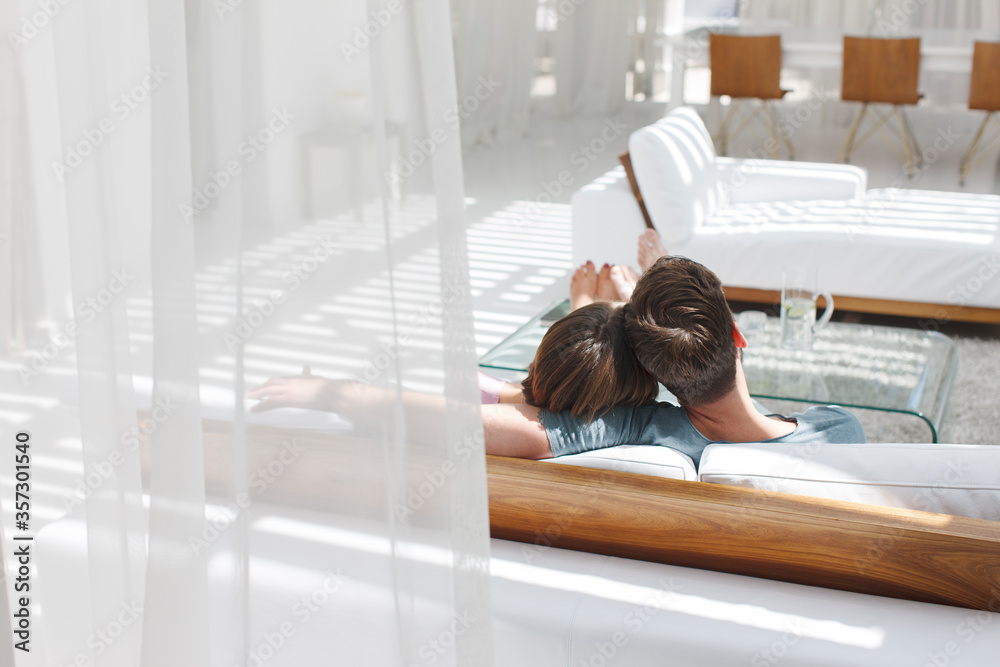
(539, 403), (865, 467)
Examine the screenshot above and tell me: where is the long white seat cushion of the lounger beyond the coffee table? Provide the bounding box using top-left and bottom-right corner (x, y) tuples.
(670, 190), (1000, 308)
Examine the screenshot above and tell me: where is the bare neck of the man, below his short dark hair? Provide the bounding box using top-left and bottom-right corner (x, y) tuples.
(683, 362), (796, 442)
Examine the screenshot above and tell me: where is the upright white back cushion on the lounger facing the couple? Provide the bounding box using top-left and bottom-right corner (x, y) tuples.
(628, 107), (720, 249)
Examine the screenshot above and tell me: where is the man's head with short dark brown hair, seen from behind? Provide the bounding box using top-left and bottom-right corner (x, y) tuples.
(625, 256), (737, 406)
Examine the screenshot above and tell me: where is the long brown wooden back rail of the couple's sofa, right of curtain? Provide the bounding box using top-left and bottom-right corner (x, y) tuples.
(487, 456), (1000, 611)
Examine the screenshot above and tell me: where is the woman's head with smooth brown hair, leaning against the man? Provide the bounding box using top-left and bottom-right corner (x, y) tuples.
(522, 301), (659, 419)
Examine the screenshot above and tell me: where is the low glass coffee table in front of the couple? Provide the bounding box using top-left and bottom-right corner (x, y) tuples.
(479, 301), (958, 442)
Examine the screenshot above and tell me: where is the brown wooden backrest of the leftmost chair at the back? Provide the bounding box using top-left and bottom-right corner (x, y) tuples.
(708, 33), (785, 100)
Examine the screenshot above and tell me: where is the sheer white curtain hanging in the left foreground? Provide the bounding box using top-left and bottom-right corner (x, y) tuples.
(0, 0), (493, 666)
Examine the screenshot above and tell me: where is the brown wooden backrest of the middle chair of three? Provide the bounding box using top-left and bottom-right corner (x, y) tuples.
(840, 36), (920, 104)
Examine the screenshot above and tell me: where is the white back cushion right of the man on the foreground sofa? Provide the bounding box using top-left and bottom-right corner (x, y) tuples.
(699, 443), (1000, 521)
